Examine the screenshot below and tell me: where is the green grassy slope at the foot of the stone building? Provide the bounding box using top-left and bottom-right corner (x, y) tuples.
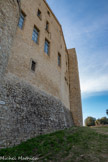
(0, 127), (108, 162)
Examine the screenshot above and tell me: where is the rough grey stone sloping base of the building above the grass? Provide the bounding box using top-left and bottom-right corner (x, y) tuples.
(0, 75), (73, 148)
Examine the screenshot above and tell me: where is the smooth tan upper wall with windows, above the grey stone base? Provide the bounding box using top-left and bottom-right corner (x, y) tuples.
(7, 0), (70, 109)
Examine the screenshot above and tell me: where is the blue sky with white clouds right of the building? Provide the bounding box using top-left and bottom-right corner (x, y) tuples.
(47, 0), (108, 123)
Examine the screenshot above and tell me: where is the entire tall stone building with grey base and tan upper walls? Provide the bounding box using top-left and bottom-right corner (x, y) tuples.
(0, 0), (82, 147)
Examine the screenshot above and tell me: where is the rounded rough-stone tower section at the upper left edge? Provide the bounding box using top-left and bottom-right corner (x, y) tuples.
(0, 0), (19, 81)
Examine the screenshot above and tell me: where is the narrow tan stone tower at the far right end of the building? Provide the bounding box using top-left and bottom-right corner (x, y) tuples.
(68, 48), (83, 126)
